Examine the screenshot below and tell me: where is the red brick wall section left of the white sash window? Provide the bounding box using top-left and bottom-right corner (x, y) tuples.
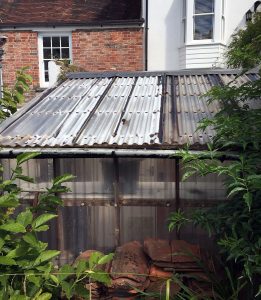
(3, 31), (39, 86)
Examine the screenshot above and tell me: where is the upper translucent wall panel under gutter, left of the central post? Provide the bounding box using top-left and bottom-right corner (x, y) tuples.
(57, 158), (114, 200)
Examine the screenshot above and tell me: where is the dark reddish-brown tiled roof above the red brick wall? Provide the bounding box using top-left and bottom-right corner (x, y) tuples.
(0, 0), (142, 28)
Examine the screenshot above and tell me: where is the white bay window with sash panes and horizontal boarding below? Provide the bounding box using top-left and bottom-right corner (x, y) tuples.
(179, 0), (226, 69)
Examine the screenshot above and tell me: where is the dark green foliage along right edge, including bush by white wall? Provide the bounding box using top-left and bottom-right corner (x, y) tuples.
(169, 11), (261, 299)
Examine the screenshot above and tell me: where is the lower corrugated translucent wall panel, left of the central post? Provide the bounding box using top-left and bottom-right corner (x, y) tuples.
(60, 206), (115, 260)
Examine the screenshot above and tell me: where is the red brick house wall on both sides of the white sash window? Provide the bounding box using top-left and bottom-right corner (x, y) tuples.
(3, 28), (143, 87)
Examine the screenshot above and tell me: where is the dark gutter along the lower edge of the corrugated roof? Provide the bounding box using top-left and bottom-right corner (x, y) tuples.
(0, 148), (238, 160)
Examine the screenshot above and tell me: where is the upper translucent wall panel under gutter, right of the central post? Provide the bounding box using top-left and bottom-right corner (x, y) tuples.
(119, 158), (175, 200)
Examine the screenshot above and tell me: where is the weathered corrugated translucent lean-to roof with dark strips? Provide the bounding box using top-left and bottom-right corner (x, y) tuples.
(0, 71), (259, 150)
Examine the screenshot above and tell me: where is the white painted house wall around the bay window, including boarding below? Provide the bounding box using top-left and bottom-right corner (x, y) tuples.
(146, 0), (255, 71)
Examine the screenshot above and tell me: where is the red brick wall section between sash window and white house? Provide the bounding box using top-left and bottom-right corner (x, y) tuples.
(72, 28), (144, 71)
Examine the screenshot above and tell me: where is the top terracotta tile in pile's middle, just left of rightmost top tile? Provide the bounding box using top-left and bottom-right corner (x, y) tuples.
(144, 239), (171, 262)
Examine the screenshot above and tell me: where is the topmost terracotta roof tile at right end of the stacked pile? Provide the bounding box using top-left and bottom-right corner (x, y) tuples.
(171, 240), (201, 263)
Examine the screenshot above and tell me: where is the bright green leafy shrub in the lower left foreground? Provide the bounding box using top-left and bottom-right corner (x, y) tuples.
(0, 153), (113, 300)
